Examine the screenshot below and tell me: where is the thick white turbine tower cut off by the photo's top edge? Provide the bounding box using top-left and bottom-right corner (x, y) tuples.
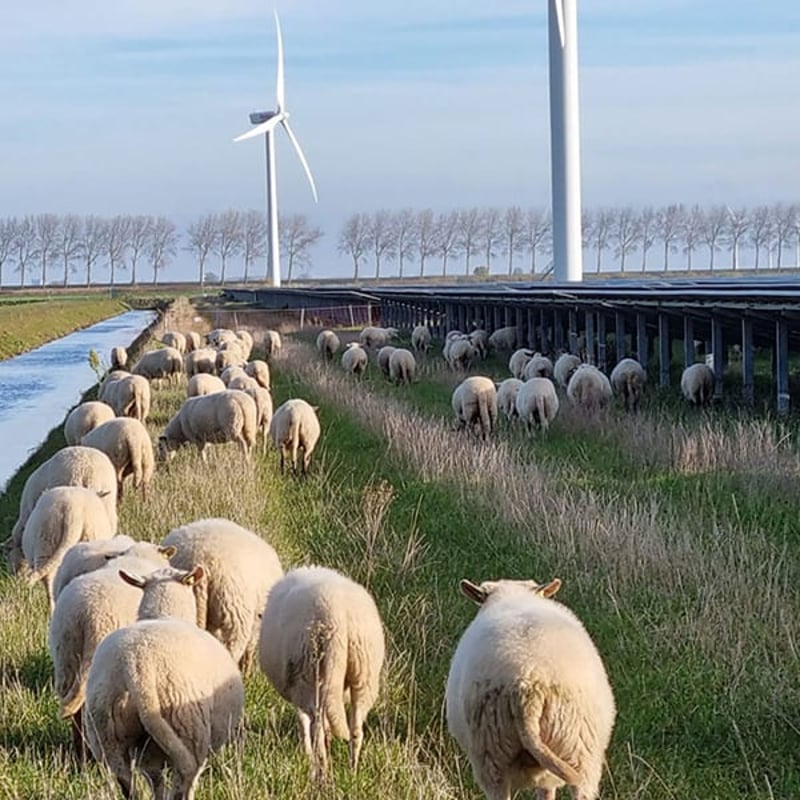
(547, 0), (583, 281)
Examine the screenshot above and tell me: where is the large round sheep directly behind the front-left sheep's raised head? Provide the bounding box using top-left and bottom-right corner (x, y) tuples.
(163, 519), (283, 668)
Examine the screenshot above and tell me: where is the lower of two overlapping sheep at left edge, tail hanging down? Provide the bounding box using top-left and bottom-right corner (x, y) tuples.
(7, 486), (117, 614)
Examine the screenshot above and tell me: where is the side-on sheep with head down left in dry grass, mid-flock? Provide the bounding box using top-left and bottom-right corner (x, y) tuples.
(158, 389), (257, 461)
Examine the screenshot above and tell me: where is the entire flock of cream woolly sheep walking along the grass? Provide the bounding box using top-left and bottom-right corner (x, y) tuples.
(0, 312), (713, 800)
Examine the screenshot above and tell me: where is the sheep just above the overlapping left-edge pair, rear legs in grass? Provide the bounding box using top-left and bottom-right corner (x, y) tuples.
(81, 417), (156, 500)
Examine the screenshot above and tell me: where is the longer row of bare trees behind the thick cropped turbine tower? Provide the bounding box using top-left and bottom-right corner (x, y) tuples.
(338, 203), (800, 280)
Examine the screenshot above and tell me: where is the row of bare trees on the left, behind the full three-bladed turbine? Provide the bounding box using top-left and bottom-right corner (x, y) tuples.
(0, 209), (322, 287)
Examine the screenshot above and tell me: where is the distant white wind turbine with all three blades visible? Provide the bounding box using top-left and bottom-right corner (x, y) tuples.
(233, 10), (317, 286)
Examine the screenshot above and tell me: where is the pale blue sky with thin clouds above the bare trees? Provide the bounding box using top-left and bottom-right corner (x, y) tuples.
(0, 0), (800, 280)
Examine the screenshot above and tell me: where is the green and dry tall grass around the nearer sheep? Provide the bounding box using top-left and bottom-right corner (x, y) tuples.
(0, 326), (800, 800)
